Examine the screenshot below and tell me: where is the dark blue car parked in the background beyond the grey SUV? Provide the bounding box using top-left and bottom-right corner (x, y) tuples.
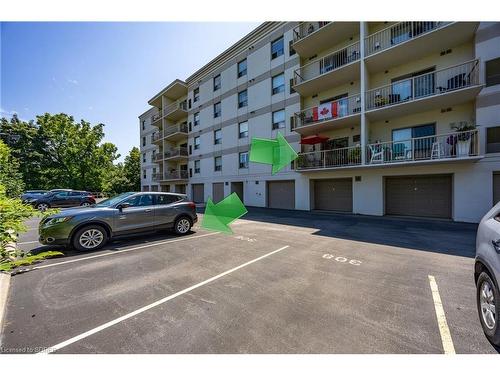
(26, 189), (95, 211)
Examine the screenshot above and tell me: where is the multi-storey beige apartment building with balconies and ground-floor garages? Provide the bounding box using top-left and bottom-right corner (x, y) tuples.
(139, 22), (500, 222)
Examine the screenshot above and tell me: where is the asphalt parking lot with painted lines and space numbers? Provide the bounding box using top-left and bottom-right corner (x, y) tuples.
(1, 209), (497, 353)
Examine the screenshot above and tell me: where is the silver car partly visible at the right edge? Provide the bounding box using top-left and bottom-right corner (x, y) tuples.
(474, 203), (500, 346)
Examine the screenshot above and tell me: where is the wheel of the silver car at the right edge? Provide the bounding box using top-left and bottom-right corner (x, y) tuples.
(476, 272), (500, 345)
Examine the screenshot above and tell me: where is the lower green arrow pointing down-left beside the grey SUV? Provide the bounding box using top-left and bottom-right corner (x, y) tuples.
(201, 193), (248, 234)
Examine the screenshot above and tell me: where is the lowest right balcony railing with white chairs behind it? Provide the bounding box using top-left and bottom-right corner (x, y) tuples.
(366, 129), (479, 164)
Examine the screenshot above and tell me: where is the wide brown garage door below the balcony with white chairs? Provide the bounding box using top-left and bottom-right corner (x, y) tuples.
(385, 175), (452, 219)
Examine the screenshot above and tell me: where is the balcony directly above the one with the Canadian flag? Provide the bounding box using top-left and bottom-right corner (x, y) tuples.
(293, 42), (361, 96)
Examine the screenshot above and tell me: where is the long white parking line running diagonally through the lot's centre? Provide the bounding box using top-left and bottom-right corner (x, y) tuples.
(38, 245), (289, 354)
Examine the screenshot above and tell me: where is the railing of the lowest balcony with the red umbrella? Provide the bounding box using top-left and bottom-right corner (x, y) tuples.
(295, 145), (361, 170)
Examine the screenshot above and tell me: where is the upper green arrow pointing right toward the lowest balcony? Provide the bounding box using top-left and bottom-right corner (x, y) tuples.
(250, 133), (298, 174)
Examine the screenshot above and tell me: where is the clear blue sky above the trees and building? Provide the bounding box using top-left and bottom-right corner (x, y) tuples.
(0, 22), (259, 159)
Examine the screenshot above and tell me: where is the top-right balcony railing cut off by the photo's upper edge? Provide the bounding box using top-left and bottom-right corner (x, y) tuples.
(365, 22), (451, 56)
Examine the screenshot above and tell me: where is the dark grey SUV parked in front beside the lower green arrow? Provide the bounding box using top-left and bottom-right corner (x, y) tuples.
(39, 192), (198, 251)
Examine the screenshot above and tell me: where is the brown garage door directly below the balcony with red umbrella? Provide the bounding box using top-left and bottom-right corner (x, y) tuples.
(314, 178), (352, 212)
